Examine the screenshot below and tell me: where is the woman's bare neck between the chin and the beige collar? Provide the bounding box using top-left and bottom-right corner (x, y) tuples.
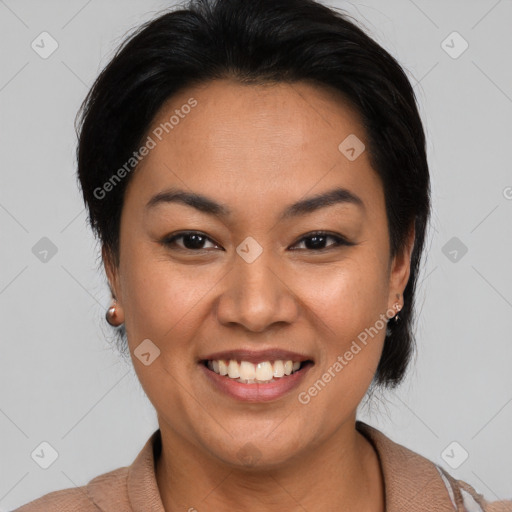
(156, 421), (385, 512)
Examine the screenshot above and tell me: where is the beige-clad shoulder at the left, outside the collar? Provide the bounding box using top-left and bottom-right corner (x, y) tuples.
(13, 467), (129, 512)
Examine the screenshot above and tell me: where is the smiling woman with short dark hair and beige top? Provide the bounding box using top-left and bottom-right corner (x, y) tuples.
(13, 0), (512, 512)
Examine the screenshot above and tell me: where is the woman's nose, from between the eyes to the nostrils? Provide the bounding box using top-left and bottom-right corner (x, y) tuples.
(217, 246), (299, 332)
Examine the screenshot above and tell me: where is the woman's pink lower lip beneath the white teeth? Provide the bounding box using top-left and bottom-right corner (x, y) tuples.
(199, 363), (313, 402)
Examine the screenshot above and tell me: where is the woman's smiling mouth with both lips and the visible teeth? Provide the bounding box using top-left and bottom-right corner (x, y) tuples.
(199, 350), (315, 402)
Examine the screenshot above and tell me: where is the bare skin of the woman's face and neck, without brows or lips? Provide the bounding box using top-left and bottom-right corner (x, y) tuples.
(104, 79), (414, 512)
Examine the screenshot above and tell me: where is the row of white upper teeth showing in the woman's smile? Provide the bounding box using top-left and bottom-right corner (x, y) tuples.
(208, 359), (300, 383)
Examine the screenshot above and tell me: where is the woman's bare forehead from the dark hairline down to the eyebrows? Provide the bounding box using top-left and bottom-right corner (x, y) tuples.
(123, 80), (381, 218)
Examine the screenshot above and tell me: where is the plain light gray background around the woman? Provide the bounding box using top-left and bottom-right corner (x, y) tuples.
(0, 0), (512, 511)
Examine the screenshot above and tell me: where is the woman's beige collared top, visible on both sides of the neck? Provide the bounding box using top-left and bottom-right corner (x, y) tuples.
(13, 421), (512, 512)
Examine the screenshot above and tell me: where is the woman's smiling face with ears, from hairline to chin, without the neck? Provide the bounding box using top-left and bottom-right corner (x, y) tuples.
(106, 80), (412, 466)
